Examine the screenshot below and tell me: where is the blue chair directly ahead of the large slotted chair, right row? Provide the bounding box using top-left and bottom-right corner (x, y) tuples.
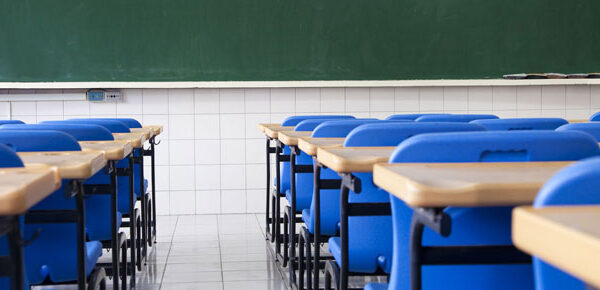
(321, 122), (485, 288)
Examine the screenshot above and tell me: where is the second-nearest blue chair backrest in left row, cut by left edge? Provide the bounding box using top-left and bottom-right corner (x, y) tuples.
(0, 130), (81, 152)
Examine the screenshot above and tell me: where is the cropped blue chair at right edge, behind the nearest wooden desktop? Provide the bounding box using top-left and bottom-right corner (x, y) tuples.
(533, 157), (600, 290)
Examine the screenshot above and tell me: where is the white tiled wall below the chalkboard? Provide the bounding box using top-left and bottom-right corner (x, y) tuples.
(0, 86), (600, 214)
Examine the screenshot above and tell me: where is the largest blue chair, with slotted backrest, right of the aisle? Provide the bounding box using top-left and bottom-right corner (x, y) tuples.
(365, 131), (600, 289)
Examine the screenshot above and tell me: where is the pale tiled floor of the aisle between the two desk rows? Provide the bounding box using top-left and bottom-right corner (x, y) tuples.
(37, 214), (287, 290)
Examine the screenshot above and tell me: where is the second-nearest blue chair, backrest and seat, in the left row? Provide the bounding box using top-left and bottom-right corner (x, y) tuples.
(0, 130), (110, 284)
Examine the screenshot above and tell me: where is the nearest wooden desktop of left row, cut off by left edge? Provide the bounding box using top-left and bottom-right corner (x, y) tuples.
(0, 164), (60, 216)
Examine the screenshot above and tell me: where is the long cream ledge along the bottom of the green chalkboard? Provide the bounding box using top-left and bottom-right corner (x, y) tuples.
(0, 79), (600, 89)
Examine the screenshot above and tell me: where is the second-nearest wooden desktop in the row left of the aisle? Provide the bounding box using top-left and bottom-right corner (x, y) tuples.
(17, 150), (106, 179)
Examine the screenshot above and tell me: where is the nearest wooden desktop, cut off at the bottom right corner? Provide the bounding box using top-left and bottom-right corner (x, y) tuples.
(512, 206), (600, 287)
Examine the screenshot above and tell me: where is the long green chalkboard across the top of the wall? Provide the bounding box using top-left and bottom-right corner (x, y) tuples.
(0, 0), (600, 82)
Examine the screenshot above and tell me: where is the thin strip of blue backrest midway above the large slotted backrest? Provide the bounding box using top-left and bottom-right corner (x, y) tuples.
(471, 118), (569, 131)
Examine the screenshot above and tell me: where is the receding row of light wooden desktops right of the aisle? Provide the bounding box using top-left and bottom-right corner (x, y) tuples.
(259, 124), (600, 287)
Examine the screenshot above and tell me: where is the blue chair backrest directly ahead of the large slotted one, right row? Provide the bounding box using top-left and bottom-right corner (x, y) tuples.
(344, 122), (485, 147)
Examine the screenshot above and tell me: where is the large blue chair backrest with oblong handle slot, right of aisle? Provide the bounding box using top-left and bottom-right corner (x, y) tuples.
(391, 131), (600, 162)
